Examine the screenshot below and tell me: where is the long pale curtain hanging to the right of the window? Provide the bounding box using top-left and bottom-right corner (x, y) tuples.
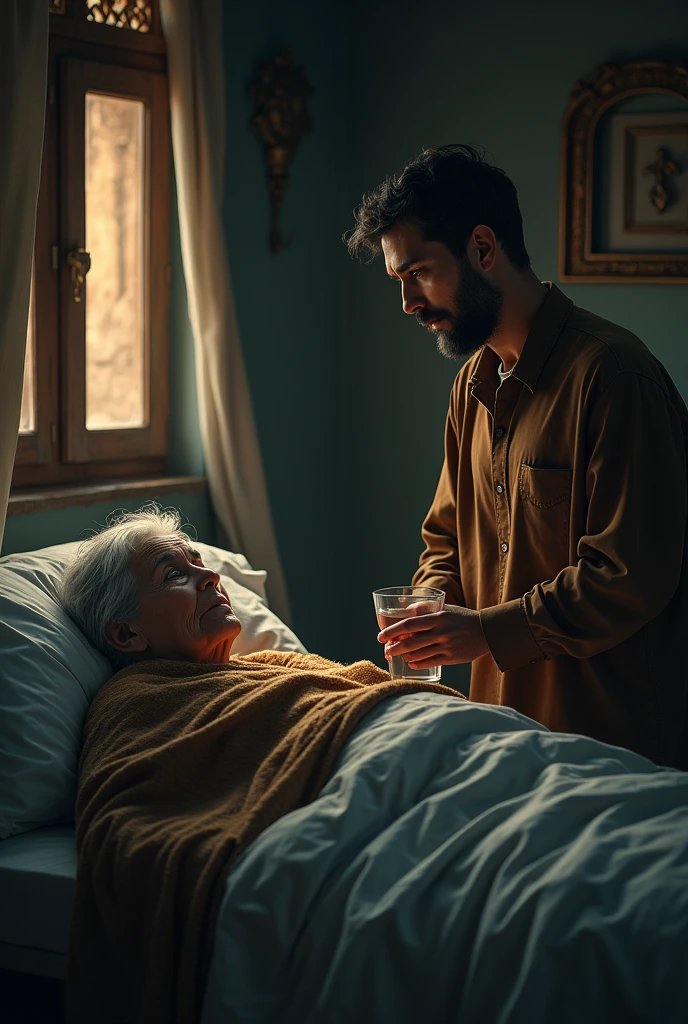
(161, 0), (291, 622)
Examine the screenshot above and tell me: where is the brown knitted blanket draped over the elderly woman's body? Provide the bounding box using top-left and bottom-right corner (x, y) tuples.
(67, 651), (458, 1024)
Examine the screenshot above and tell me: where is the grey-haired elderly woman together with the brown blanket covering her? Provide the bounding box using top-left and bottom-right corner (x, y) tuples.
(60, 507), (458, 1024)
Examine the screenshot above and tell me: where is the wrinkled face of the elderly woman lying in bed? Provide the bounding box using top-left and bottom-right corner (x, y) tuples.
(109, 537), (242, 663)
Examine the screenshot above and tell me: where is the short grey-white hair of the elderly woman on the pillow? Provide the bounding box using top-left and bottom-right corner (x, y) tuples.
(58, 504), (189, 669)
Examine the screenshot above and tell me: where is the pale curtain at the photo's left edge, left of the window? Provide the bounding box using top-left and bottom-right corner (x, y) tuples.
(0, 0), (49, 541)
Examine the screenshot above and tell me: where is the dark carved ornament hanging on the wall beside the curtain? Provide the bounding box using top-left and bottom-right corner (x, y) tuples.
(249, 47), (313, 253)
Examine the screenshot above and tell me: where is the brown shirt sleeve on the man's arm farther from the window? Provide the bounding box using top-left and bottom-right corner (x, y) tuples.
(480, 372), (687, 672)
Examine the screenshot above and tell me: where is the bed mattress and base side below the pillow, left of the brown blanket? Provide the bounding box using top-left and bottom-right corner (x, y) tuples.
(0, 825), (77, 978)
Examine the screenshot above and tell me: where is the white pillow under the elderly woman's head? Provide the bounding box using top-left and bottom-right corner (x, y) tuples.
(0, 542), (305, 839)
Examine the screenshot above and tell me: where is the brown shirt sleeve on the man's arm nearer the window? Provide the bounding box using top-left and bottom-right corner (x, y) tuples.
(412, 392), (466, 605)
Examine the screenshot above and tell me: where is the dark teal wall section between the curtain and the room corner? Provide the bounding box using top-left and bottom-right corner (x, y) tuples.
(224, 0), (351, 657)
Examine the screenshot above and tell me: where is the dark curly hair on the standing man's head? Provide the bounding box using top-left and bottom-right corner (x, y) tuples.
(344, 144), (530, 269)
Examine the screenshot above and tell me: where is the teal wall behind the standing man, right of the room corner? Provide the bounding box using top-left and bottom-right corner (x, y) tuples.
(342, 0), (688, 678)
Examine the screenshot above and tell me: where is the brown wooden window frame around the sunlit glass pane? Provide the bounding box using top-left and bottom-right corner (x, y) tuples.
(12, 0), (171, 490)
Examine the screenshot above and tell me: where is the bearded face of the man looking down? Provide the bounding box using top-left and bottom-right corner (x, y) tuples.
(382, 221), (503, 359)
